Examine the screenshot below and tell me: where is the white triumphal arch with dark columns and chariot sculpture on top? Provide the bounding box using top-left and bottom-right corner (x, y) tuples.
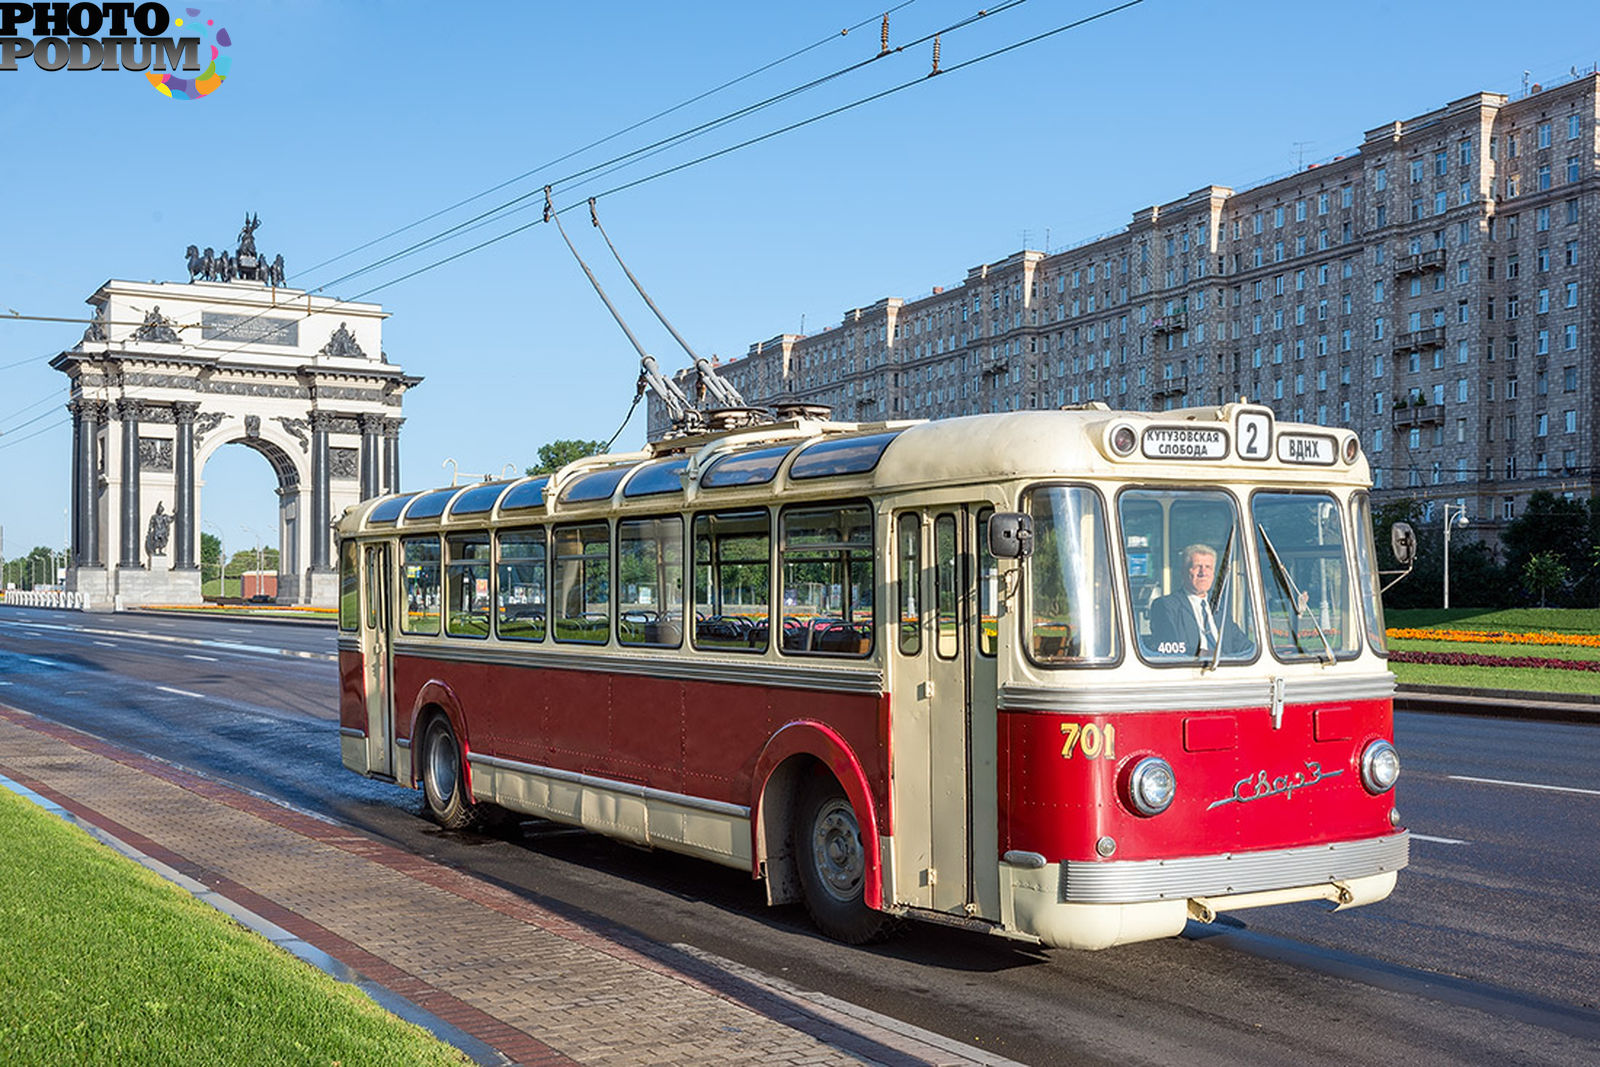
(51, 216), (421, 609)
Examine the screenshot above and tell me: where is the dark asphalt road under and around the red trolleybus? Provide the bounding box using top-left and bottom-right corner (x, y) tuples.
(0, 606), (1600, 1065)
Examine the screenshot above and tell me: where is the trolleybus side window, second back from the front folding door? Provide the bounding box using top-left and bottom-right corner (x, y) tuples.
(694, 510), (773, 653)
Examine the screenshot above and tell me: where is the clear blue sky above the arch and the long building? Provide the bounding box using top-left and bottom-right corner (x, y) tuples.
(0, 0), (1600, 555)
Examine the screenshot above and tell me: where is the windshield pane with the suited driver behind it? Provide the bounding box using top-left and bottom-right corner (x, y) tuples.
(1117, 490), (1258, 665)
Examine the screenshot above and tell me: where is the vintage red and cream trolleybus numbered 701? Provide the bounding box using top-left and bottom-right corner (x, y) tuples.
(339, 403), (1408, 949)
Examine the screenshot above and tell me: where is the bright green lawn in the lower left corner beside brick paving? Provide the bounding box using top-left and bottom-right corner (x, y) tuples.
(0, 789), (466, 1067)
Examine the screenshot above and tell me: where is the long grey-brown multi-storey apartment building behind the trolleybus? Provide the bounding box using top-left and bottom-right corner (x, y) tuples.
(650, 72), (1600, 526)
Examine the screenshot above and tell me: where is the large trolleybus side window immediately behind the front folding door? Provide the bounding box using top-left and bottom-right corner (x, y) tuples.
(779, 504), (874, 656)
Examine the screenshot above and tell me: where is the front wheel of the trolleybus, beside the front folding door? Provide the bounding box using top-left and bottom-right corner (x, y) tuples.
(794, 776), (893, 945)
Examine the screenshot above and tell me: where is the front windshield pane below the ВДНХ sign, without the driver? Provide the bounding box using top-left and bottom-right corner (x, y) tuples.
(1250, 493), (1360, 659)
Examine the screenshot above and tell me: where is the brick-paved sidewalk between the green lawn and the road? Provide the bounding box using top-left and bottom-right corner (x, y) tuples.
(0, 705), (1008, 1065)
